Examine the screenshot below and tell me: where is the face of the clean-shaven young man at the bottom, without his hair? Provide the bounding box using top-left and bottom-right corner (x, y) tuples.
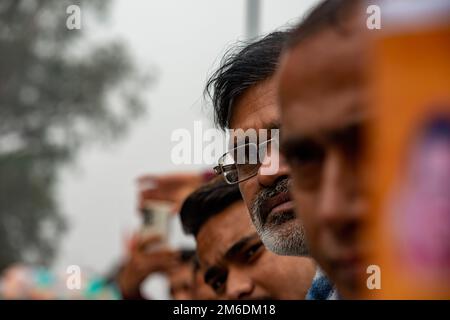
(196, 202), (315, 299)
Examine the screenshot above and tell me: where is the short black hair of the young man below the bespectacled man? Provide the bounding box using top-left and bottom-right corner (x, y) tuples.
(180, 178), (242, 236)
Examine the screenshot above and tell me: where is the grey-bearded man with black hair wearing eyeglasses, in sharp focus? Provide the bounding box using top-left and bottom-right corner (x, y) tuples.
(206, 32), (308, 256)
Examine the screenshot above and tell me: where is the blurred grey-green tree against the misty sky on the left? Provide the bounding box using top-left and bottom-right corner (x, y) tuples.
(0, 0), (150, 270)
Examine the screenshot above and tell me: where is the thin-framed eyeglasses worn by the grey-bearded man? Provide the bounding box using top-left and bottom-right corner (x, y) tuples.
(214, 138), (279, 184)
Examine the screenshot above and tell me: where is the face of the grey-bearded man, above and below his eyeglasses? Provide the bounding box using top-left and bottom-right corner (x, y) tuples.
(230, 78), (307, 256)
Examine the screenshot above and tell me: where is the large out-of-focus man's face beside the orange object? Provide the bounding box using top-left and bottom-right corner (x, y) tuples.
(278, 12), (367, 297)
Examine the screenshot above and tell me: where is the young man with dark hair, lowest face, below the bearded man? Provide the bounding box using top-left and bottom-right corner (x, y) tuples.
(180, 180), (315, 299)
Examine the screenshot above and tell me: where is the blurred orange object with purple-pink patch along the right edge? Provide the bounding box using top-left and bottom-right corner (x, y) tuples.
(369, 0), (450, 299)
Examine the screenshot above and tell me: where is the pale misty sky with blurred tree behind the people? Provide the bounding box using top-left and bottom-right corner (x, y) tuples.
(0, 0), (318, 298)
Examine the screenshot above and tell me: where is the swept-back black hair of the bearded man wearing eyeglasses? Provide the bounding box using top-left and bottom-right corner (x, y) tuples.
(205, 31), (289, 129)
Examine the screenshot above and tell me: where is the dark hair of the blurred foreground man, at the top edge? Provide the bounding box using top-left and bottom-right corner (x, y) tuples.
(286, 0), (362, 48)
